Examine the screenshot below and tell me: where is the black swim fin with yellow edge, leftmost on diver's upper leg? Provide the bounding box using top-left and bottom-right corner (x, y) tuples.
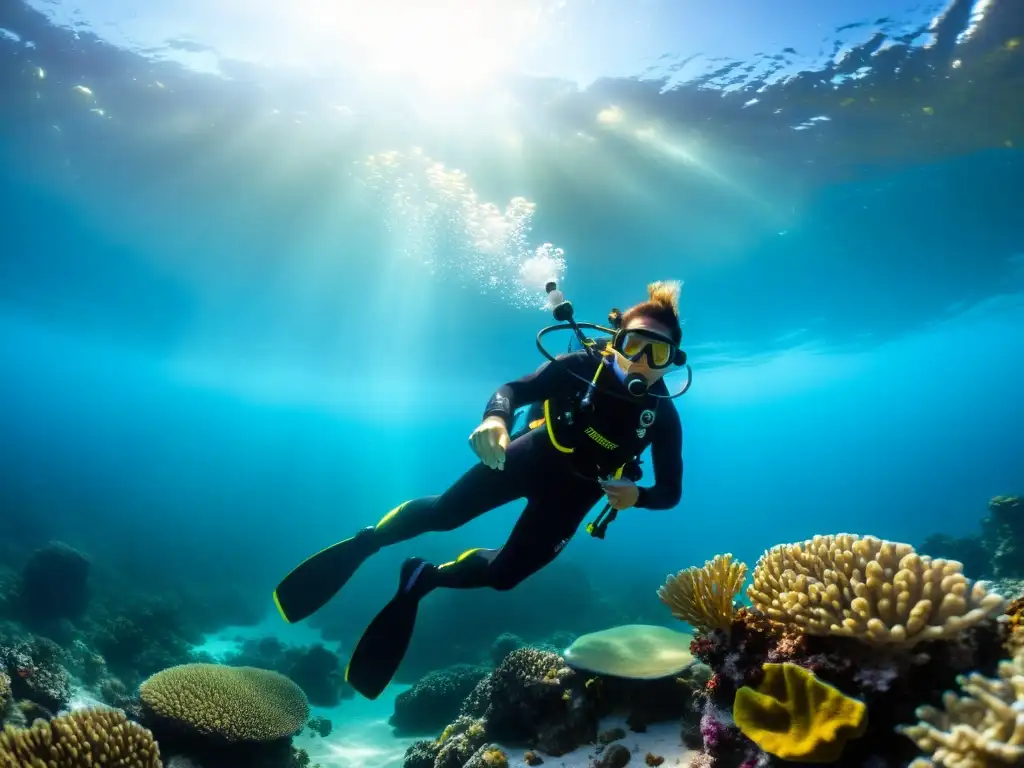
(273, 527), (377, 624)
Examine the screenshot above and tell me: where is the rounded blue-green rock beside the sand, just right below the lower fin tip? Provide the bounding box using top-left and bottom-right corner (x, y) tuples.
(388, 664), (487, 733)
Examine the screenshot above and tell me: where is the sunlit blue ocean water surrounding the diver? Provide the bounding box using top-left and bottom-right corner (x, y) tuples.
(0, 0), (1024, 768)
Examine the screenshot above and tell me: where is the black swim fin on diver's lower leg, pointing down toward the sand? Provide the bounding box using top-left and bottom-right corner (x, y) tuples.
(345, 557), (433, 699)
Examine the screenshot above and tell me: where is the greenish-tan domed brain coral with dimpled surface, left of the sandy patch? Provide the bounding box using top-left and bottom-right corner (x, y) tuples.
(139, 664), (309, 741)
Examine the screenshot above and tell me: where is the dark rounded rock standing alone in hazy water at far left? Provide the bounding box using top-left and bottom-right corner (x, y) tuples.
(11, 542), (91, 628)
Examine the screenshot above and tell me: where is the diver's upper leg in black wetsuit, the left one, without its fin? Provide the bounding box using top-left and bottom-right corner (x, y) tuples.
(365, 434), (545, 549)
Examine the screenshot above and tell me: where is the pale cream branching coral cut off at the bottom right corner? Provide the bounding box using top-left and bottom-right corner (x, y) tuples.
(896, 652), (1024, 768)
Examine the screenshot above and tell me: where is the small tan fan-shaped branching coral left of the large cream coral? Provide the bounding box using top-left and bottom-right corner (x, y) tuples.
(657, 554), (746, 632)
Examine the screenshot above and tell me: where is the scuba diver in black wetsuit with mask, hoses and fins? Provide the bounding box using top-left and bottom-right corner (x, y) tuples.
(273, 282), (692, 698)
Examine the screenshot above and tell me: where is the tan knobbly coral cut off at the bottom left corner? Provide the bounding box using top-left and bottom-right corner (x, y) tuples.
(0, 709), (162, 768)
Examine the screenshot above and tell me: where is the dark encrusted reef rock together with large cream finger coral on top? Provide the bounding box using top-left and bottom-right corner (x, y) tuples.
(663, 535), (1019, 768)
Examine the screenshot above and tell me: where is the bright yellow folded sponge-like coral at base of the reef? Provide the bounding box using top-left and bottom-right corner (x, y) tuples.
(732, 664), (867, 763)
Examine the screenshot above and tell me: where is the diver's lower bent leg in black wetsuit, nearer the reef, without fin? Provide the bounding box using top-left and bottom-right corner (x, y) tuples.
(419, 478), (601, 594)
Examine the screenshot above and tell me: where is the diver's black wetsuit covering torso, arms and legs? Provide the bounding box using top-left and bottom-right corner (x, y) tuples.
(364, 351), (683, 590)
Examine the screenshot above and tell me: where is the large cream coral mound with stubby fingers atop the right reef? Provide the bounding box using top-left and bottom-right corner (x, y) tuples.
(746, 534), (1007, 646)
